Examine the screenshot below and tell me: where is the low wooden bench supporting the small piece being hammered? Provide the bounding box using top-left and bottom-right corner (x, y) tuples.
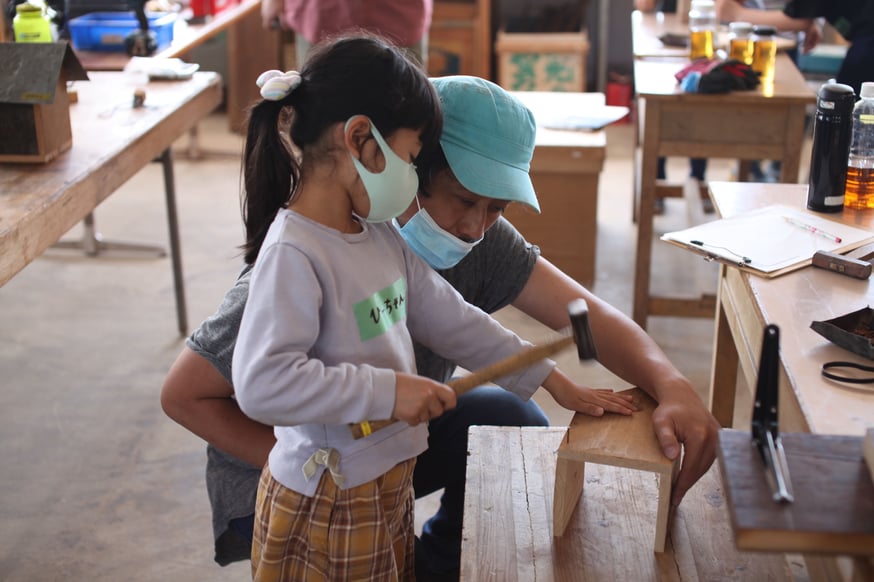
(461, 426), (793, 582)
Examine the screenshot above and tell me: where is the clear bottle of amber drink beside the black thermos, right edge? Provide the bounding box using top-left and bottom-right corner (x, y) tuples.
(844, 81), (874, 210)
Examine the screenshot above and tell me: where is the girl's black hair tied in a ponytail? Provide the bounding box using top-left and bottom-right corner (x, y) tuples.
(242, 33), (442, 263)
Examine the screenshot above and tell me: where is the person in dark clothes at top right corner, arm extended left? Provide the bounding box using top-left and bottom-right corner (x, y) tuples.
(716, 0), (874, 95)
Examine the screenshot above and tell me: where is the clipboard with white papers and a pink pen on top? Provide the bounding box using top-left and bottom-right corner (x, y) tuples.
(660, 204), (874, 278)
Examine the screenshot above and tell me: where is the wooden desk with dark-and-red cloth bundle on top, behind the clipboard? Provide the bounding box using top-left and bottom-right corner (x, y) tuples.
(633, 53), (816, 327)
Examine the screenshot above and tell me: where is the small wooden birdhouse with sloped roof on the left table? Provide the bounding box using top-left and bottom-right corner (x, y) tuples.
(0, 42), (88, 163)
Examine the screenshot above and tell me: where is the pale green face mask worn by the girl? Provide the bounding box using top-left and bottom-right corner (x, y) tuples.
(346, 117), (419, 222)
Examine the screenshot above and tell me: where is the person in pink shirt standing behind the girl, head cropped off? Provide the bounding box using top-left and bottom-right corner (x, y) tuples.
(261, 0), (434, 70)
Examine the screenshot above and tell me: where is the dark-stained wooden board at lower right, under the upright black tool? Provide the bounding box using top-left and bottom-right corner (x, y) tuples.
(718, 430), (874, 555)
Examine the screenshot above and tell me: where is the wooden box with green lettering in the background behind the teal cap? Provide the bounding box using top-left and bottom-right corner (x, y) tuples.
(495, 31), (589, 92)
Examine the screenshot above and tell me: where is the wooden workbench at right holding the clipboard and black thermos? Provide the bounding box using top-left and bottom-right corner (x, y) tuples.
(709, 182), (874, 580)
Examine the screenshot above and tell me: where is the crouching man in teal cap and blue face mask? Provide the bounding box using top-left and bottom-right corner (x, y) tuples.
(162, 76), (718, 579)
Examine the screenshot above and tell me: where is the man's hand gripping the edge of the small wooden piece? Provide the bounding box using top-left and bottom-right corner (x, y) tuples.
(652, 398), (719, 505)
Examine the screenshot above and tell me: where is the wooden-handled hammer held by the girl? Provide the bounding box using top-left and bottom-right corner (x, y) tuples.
(349, 298), (598, 439)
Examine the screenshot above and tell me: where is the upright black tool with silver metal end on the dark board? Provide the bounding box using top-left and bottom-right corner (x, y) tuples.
(753, 324), (795, 503)
